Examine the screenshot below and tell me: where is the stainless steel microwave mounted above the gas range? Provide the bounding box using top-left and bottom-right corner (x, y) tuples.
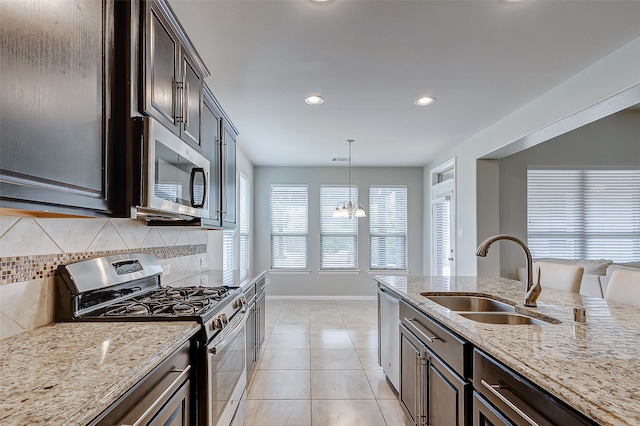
(136, 117), (209, 220)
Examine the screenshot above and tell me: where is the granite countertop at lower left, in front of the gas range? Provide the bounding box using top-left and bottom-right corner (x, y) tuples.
(0, 321), (200, 426)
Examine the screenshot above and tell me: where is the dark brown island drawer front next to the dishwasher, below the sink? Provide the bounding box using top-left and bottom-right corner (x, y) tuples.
(400, 301), (471, 378)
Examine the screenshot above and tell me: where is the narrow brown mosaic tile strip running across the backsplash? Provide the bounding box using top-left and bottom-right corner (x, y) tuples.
(0, 244), (207, 285)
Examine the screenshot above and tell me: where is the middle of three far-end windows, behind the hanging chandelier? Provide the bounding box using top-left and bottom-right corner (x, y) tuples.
(320, 185), (358, 269)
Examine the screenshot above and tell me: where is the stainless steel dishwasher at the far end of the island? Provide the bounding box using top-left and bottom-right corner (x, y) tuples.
(378, 286), (400, 391)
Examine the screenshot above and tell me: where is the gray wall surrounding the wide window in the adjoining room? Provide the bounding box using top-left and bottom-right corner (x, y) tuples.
(500, 110), (640, 278)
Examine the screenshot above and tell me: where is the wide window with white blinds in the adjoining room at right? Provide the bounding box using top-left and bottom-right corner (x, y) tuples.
(527, 170), (640, 262)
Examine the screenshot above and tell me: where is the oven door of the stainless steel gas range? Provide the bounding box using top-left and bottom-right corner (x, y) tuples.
(206, 310), (247, 426)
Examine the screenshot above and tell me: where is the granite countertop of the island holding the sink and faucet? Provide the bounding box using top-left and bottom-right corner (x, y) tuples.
(375, 276), (640, 425)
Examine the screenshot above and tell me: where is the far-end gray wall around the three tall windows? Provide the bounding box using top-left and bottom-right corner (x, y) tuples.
(253, 166), (423, 297)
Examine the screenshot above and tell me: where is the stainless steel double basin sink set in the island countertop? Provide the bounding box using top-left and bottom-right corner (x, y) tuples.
(422, 293), (549, 325)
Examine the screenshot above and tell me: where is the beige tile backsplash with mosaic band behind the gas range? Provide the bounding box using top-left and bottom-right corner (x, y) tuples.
(0, 215), (221, 338)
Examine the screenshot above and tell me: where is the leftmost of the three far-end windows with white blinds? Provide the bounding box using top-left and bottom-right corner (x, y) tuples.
(271, 185), (309, 270)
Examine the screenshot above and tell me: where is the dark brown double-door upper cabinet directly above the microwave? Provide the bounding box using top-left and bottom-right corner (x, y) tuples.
(141, 0), (209, 150)
